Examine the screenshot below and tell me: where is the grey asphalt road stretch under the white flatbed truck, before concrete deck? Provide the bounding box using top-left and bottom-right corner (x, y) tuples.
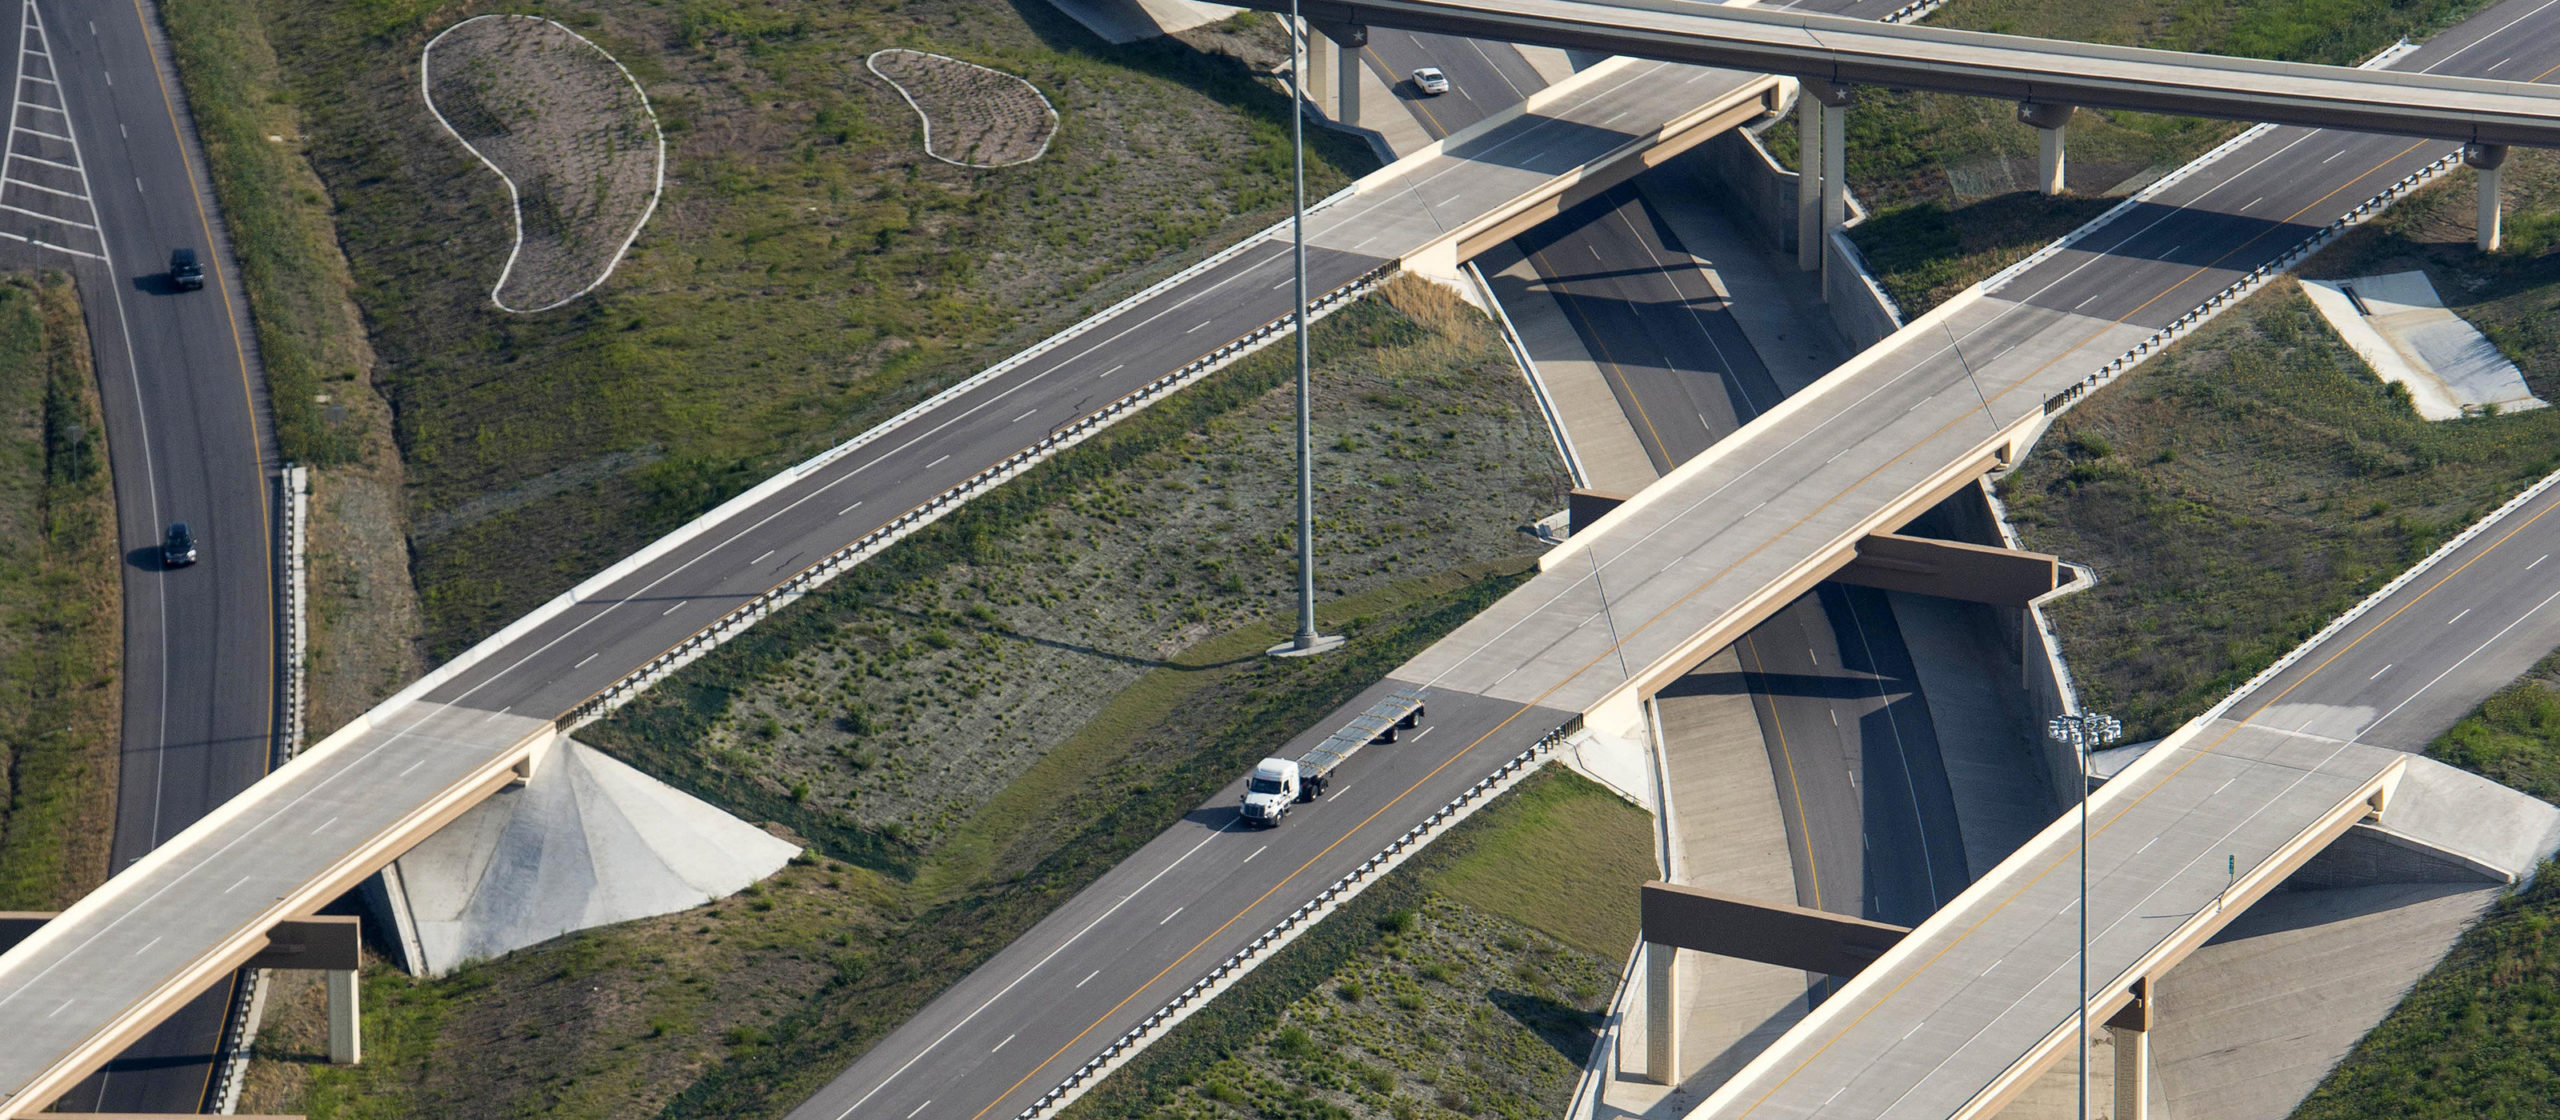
(791, 680), (1572, 1120)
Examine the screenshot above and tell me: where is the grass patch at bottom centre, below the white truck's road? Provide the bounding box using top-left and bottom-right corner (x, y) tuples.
(1068, 767), (1654, 1120)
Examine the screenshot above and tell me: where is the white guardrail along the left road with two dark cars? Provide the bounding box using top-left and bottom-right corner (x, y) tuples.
(205, 465), (312, 1115)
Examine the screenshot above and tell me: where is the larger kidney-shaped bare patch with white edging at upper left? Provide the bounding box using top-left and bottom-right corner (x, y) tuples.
(420, 15), (666, 312)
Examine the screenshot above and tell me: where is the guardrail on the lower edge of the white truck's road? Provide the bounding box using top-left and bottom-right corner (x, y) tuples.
(1014, 719), (1582, 1120)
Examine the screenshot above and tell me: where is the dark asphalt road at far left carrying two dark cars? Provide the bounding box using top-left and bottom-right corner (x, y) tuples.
(0, 0), (274, 1112)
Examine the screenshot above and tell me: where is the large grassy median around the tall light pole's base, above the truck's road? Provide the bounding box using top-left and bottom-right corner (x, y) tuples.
(251, 276), (1556, 1117)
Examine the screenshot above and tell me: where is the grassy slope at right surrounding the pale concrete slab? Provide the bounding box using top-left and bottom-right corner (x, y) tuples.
(2002, 153), (2560, 739)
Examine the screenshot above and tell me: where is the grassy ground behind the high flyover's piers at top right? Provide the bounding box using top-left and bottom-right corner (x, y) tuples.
(1772, 0), (2488, 315)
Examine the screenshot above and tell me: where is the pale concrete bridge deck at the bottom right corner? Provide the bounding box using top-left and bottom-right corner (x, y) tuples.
(1690, 719), (2406, 1120)
